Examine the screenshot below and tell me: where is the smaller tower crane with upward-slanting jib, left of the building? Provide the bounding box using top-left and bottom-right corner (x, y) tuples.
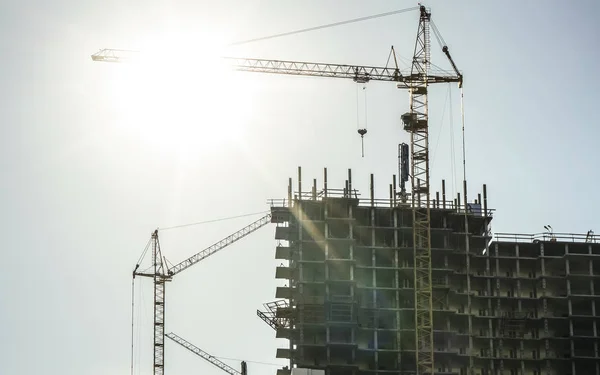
(133, 213), (271, 375)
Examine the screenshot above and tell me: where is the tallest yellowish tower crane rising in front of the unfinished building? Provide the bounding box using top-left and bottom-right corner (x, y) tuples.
(92, 5), (463, 375)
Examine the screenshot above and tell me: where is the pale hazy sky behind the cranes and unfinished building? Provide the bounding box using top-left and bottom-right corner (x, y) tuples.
(0, 0), (600, 375)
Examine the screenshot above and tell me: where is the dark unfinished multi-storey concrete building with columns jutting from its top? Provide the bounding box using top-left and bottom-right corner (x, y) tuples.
(263, 171), (600, 375)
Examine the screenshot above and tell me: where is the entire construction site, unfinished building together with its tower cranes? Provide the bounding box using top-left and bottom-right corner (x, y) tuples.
(92, 5), (600, 375)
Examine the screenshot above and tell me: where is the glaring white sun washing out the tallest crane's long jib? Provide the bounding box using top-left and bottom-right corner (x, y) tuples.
(109, 33), (252, 159)
